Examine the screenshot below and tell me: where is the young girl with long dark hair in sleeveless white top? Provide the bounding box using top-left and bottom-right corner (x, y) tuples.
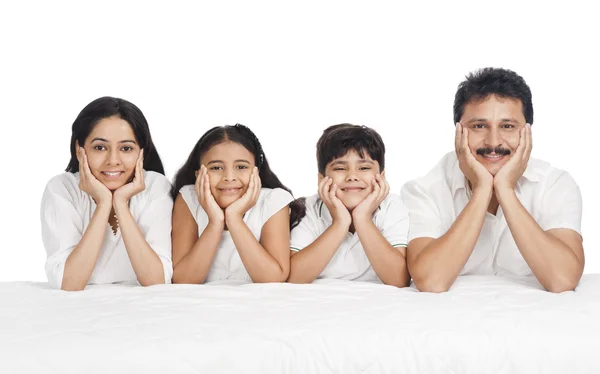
(172, 124), (303, 283)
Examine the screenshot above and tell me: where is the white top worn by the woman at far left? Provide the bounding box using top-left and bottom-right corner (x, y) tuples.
(40, 171), (173, 288)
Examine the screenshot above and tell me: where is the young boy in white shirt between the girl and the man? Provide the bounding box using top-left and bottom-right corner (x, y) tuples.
(288, 124), (410, 287)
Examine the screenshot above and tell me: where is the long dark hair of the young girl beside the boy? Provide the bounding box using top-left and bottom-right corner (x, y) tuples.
(171, 124), (306, 230)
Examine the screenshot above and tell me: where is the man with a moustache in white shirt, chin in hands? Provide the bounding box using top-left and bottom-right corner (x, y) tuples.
(402, 68), (584, 292)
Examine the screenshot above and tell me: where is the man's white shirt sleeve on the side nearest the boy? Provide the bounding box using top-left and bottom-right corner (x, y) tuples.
(401, 181), (444, 243)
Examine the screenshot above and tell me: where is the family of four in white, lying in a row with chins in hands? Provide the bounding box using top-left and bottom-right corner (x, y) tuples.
(40, 68), (584, 292)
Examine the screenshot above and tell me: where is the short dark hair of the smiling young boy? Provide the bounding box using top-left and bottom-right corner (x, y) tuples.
(317, 123), (385, 175)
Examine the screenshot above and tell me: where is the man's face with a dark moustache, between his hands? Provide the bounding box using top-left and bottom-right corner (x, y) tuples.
(460, 95), (525, 175)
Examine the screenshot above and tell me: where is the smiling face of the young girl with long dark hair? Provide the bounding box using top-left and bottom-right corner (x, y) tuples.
(197, 141), (255, 209)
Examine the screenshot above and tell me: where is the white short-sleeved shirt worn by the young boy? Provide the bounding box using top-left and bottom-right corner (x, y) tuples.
(290, 194), (409, 282)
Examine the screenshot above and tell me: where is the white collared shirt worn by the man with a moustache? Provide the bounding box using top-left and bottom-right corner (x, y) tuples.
(402, 152), (582, 276)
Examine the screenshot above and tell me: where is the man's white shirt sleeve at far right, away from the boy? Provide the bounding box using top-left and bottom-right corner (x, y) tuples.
(538, 172), (582, 235)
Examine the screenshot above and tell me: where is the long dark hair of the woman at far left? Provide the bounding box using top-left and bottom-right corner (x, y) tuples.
(66, 96), (165, 175)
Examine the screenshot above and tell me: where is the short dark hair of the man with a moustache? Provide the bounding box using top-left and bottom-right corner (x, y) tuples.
(454, 67), (533, 125)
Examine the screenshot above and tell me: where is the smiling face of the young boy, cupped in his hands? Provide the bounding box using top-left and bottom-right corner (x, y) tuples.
(319, 150), (383, 210)
